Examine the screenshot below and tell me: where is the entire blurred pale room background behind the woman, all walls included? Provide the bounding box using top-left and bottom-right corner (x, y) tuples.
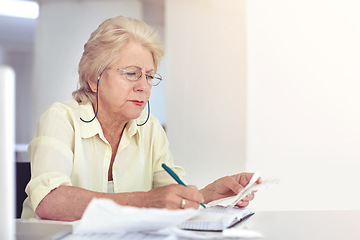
(0, 0), (360, 214)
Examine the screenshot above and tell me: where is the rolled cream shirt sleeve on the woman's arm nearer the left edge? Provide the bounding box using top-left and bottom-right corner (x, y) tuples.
(22, 104), (74, 218)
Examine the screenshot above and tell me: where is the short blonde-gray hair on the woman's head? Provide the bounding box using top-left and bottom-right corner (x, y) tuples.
(73, 16), (164, 104)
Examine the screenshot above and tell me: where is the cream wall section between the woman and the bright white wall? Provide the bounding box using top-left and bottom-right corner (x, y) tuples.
(165, 0), (246, 187)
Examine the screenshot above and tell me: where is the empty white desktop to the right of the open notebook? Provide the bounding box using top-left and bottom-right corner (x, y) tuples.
(247, 210), (360, 240)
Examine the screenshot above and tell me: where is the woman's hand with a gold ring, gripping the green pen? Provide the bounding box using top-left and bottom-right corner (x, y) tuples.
(143, 184), (204, 209)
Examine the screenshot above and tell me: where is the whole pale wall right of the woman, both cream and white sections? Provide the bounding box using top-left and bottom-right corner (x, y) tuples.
(166, 0), (360, 210)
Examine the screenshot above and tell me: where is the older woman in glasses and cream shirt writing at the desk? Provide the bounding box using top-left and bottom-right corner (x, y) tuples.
(22, 16), (254, 221)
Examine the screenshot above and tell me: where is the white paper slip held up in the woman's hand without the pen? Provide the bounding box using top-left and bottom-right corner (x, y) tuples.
(206, 173), (279, 207)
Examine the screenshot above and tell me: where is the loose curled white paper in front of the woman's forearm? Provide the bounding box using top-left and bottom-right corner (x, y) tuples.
(75, 199), (198, 233)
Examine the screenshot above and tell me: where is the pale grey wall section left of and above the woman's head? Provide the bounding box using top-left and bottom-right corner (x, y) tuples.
(33, 0), (142, 132)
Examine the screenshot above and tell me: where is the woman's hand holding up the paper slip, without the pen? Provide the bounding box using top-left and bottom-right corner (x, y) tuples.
(200, 173), (260, 207)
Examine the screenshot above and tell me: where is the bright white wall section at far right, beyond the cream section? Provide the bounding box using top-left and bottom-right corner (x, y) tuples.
(246, 0), (360, 210)
